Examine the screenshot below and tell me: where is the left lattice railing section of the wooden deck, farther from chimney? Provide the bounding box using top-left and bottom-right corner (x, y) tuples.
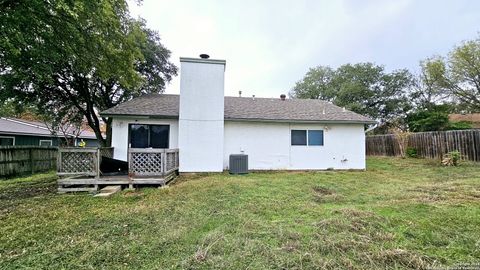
(57, 147), (113, 177)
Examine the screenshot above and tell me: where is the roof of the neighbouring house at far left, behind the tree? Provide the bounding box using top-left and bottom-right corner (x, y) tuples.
(0, 117), (96, 139)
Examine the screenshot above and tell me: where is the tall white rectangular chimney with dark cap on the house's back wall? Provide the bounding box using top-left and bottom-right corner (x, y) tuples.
(178, 55), (226, 172)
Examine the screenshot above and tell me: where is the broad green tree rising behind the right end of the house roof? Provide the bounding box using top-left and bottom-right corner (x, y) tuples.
(290, 63), (413, 127)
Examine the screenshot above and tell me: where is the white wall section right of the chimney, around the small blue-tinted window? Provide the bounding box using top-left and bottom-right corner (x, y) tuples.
(223, 121), (365, 170)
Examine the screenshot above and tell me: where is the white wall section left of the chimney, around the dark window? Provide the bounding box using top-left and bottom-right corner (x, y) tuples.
(112, 117), (178, 161)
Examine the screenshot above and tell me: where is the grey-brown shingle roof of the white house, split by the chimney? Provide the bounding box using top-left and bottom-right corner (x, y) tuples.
(101, 94), (375, 124)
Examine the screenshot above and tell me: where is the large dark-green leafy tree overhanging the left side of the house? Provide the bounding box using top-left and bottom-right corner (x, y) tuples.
(0, 0), (177, 145)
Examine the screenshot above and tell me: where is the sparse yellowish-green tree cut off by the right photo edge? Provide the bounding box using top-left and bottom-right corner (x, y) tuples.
(425, 38), (480, 112)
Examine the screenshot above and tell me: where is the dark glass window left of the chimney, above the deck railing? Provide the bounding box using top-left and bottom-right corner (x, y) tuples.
(130, 124), (170, 148)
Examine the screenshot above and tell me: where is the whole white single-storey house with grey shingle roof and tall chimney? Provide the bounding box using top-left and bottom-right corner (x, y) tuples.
(101, 58), (374, 172)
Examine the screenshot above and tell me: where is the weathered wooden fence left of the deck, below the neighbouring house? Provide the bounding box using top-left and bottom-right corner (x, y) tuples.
(0, 146), (57, 177)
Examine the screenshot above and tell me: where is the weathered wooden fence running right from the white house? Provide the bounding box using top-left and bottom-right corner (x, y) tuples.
(366, 129), (480, 161)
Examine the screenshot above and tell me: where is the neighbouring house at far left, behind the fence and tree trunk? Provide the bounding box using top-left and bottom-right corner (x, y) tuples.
(0, 117), (98, 146)
